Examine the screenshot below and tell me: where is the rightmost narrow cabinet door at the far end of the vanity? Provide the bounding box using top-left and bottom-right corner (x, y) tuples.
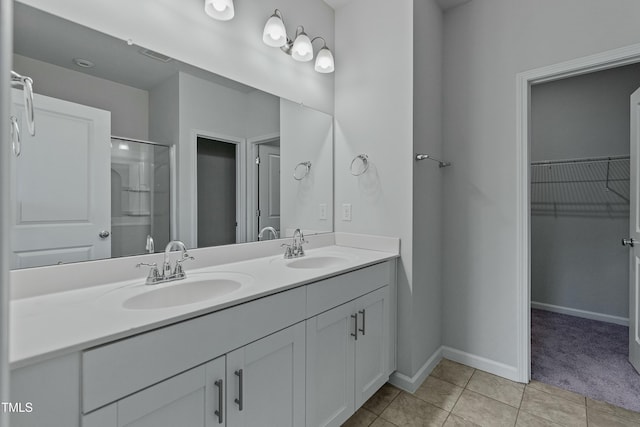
(355, 286), (389, 408)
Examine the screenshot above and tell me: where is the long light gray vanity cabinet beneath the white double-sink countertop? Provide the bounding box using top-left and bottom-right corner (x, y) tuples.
(11, 262), (395, 427)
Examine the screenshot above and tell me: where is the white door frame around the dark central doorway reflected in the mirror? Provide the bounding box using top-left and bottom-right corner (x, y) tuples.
(189, 129), (247, 248)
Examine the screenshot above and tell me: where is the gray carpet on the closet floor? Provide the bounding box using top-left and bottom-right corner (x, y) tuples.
(531, 309), (640, 412)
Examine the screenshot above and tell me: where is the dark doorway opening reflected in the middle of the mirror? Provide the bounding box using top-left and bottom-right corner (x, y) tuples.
(197, 136), (238, 247)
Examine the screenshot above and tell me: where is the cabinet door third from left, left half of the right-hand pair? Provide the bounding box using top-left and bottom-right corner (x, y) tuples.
(306, 302), (355, 427)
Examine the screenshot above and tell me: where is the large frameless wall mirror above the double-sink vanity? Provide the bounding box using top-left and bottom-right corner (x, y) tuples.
(11, 3), (334, 269)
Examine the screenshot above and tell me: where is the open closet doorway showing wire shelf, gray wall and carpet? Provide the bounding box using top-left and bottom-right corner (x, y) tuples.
(529, 64), (640, 411)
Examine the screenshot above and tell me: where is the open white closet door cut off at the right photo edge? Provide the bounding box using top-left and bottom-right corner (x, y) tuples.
(629, 89), (640, 372)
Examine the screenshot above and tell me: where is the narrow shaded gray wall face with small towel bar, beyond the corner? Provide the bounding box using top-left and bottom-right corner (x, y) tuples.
(411, 0), (448, 380)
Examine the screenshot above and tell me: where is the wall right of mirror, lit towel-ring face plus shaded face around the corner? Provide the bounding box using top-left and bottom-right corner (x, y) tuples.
(332, 0), (444, 386)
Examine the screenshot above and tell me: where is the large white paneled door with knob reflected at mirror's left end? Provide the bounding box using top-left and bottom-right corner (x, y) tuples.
(10, 89), (111, 268)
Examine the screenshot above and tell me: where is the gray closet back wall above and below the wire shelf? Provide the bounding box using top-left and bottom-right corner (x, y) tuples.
(531, 64), (640, 318)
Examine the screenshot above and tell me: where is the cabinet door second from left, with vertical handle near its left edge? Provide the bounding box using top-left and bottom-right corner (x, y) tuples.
(227, 323), (305, 427)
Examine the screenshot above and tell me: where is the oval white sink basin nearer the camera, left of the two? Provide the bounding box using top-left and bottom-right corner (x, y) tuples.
(122, 273), (250, 310)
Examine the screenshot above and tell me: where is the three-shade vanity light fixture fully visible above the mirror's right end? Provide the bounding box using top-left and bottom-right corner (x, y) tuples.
(262, 9), (334, 73)
